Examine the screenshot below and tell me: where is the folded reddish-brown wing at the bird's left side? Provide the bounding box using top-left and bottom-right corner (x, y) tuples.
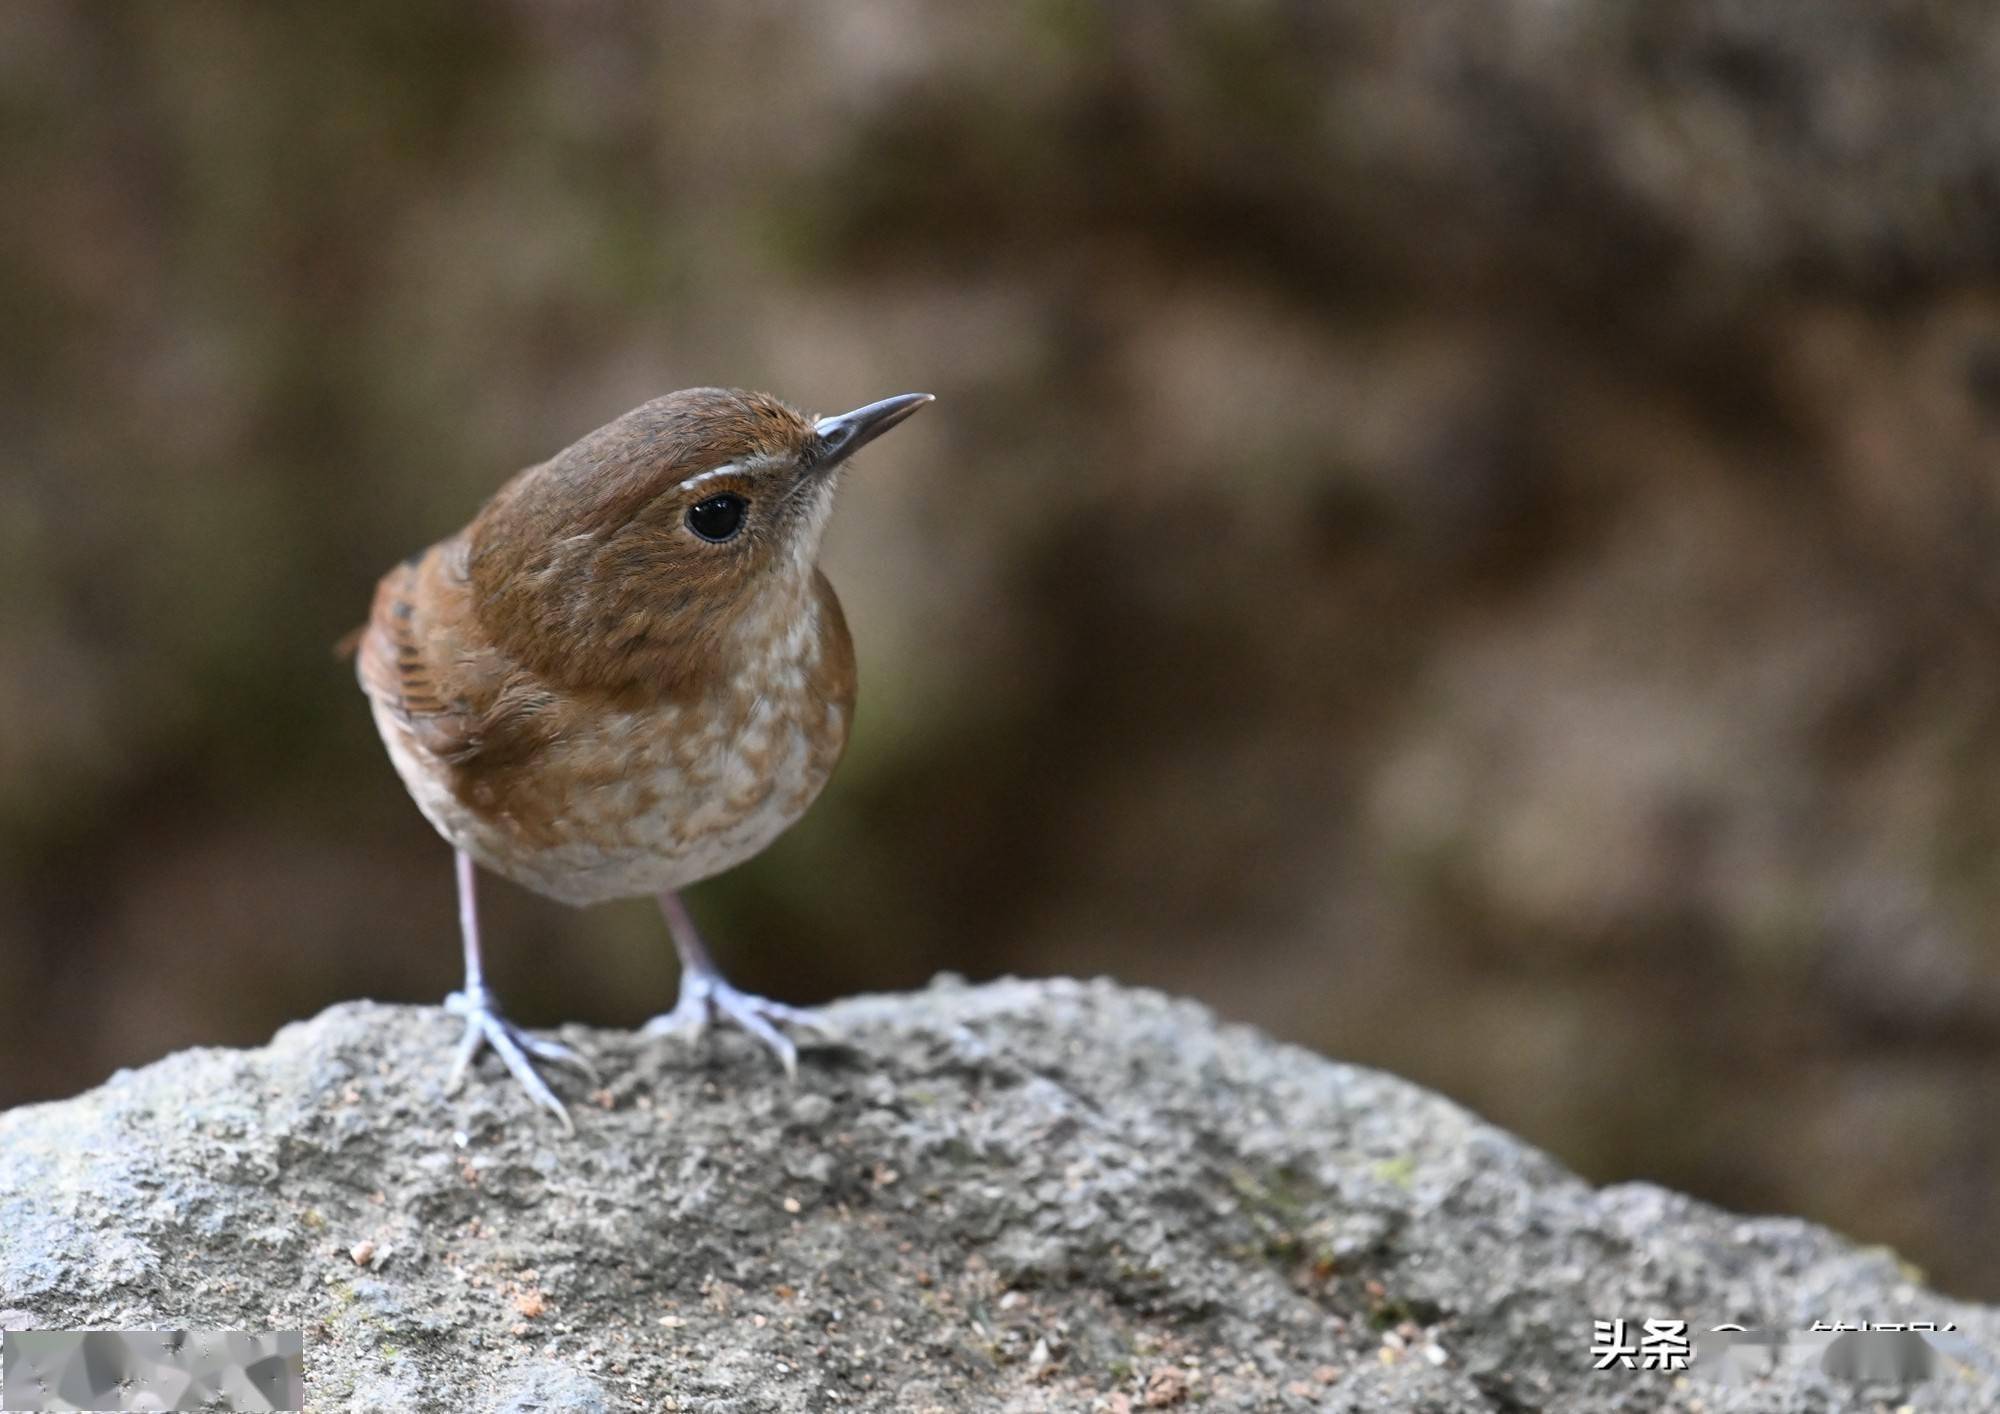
(354, 536), (552, 766)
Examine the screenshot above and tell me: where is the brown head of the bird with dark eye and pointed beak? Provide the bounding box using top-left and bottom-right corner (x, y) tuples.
(468, 388), (932, 686)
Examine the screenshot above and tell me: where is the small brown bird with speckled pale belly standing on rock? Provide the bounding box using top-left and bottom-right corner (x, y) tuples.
(356, 388), (932, 1126)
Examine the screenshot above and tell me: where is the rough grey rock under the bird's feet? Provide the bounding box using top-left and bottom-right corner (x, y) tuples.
(0, 980), (2000, 1414)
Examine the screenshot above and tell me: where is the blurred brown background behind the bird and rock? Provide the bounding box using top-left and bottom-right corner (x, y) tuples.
(0, 0), (2000, 1298)
